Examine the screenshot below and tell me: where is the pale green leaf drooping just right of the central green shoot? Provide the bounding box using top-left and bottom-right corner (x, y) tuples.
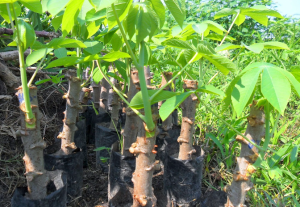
(159, 91), (193, 121)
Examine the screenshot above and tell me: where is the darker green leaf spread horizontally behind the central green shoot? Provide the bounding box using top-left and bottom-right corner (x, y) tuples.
(129, 90), (177, 109)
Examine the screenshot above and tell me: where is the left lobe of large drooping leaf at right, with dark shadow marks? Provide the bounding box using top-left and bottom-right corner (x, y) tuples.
(231, 67), (262, 117)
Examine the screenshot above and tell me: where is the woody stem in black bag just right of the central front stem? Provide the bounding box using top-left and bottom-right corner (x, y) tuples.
(177, 80), (199, 160)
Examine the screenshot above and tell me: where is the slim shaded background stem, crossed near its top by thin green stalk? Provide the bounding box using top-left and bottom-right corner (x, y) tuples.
(109, 78), (121, 131)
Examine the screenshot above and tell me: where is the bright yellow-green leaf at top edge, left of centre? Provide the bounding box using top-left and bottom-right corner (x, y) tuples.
(61, 0), (84, 37)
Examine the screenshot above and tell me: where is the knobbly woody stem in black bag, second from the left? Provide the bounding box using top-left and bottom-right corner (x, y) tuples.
(57, 72), (81, 155)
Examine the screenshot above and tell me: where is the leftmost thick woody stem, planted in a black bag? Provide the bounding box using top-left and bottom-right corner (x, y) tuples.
(16, 87), (49, 200)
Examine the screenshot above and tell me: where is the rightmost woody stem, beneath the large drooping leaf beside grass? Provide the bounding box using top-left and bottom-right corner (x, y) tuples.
(224, 101), (265, 207)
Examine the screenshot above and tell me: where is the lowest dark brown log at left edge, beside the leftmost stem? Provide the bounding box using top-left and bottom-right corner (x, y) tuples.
(0, 60), (21, 90)
